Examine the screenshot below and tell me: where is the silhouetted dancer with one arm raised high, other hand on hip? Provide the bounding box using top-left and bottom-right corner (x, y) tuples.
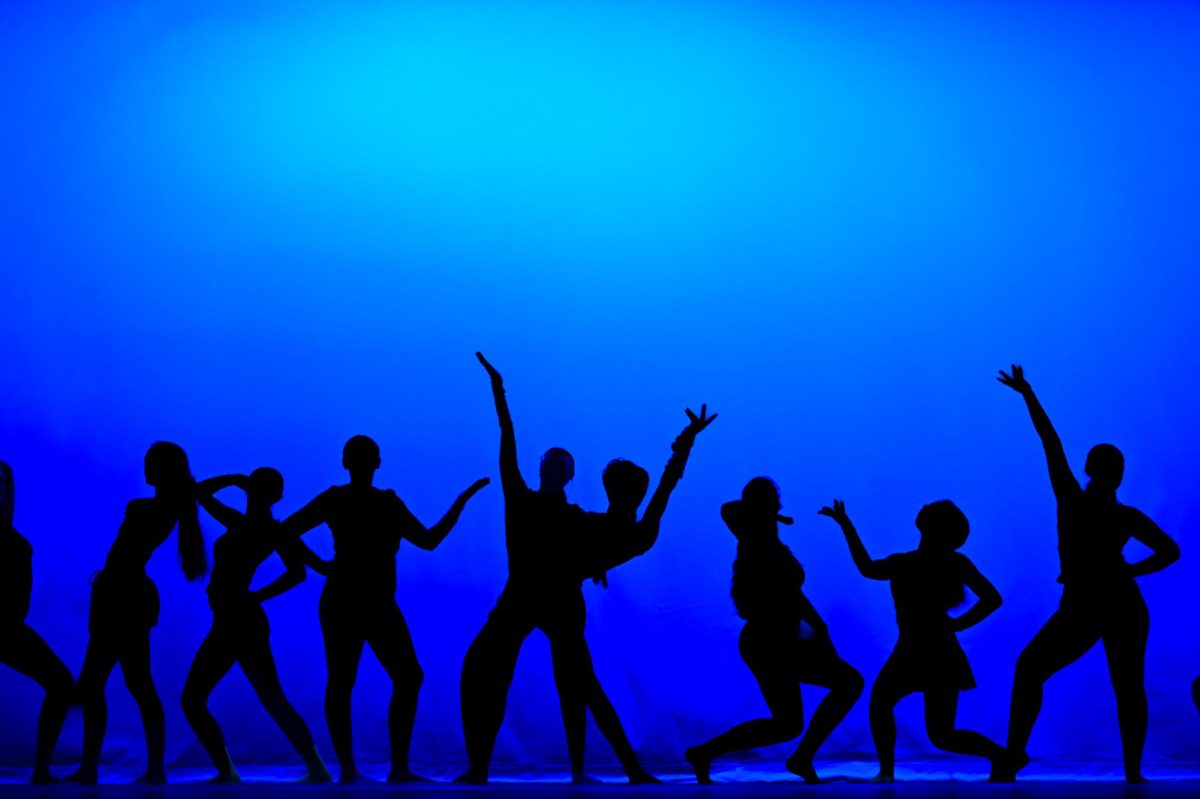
(996, 365), (1180, 782)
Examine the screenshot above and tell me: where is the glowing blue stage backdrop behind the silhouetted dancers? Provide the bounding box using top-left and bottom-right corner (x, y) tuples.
(0, 0), (1200, 771)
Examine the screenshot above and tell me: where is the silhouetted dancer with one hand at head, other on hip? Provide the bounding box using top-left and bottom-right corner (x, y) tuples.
(182, 468), (332, 783)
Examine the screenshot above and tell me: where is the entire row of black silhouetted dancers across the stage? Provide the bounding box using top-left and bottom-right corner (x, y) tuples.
(0, 354), (1180, 783)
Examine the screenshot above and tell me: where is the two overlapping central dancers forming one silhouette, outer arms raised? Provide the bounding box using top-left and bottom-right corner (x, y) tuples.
(458, 353), (715, 783)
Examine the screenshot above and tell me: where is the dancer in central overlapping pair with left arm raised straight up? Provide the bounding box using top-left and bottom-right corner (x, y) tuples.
(458, 353), (597, 783)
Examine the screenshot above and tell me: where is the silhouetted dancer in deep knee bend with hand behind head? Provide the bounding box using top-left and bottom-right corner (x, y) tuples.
(685, 477), (863, 785)
